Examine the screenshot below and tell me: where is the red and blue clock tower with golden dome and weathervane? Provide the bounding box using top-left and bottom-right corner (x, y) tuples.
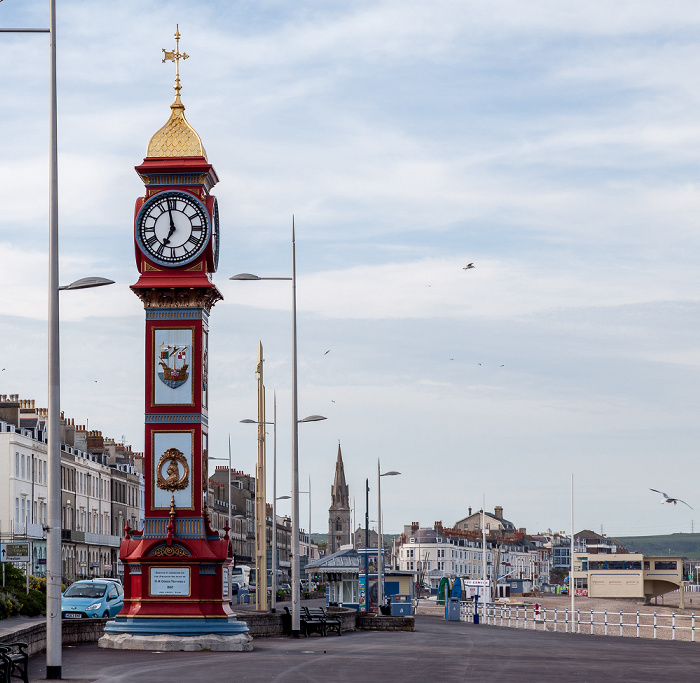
(100, 30), (251, 650)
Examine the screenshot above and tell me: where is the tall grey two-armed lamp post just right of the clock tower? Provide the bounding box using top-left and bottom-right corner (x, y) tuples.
(229, 218), (326, 638)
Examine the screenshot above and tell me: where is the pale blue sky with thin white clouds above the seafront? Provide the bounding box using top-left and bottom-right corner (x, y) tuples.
(0, 0), (700, 535)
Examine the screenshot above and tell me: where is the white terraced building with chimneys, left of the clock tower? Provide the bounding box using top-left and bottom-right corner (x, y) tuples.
(0, 395), (143, 581)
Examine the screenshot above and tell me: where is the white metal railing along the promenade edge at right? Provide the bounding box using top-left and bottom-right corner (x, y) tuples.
(460, 602), (695, 643)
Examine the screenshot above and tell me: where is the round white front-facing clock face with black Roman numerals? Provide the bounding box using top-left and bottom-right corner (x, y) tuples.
(135, 191), (209, 266)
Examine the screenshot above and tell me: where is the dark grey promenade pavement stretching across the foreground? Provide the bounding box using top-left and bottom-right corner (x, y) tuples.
(20, 616), (700, 683)
